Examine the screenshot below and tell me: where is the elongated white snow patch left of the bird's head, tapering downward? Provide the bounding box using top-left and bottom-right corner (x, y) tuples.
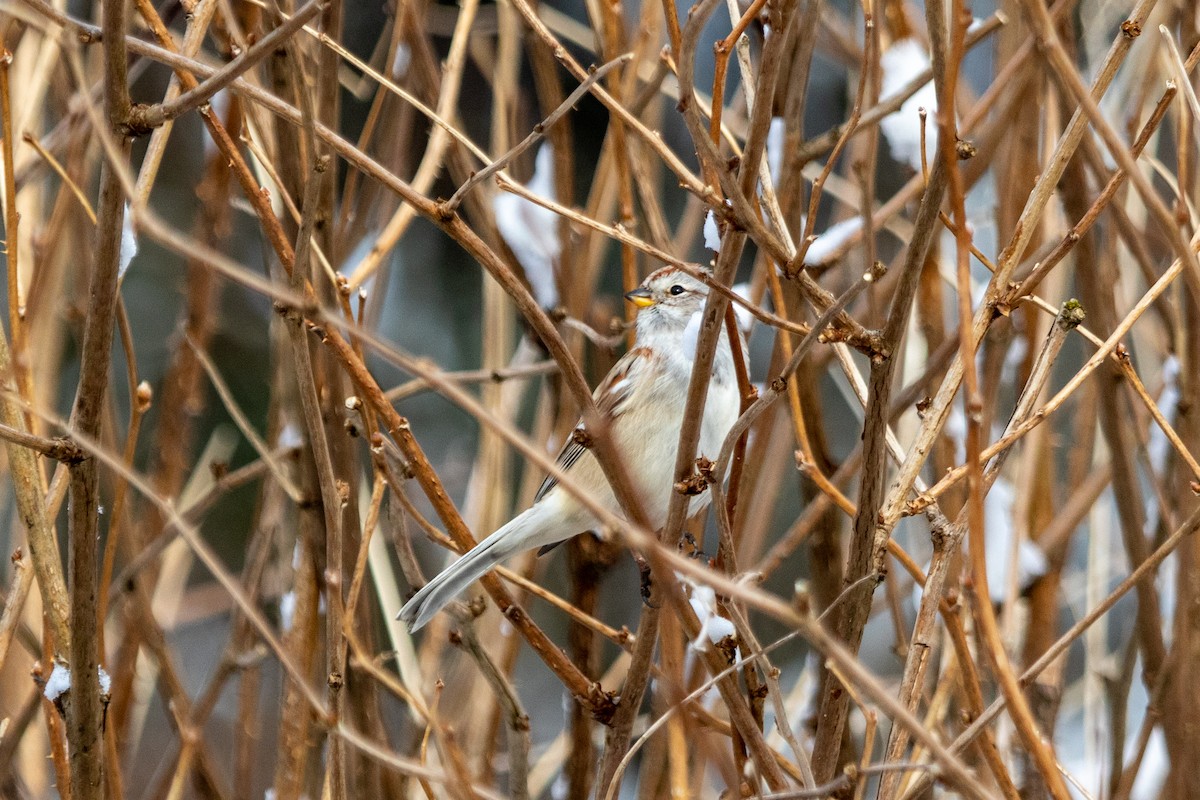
(492, 145), (563, 308)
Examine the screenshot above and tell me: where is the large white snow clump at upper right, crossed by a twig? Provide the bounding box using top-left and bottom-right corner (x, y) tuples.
(880, 38), (937, 172)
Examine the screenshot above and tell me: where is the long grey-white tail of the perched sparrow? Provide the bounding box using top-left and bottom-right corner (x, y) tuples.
(397, 504), (556, 631)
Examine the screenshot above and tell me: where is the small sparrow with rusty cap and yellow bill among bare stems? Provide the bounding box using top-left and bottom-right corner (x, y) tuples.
(397, 266), (744, 632)
